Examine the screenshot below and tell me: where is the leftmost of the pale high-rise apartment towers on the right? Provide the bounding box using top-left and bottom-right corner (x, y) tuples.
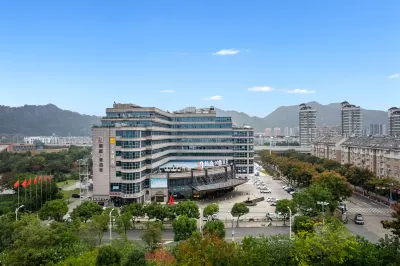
(299, 103), (317, 147)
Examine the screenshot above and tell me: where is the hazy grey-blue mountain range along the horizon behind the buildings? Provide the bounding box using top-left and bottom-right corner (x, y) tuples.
(0, 102), (387, 136)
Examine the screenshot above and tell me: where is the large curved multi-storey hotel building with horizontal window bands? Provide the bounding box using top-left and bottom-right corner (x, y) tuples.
(92, 103), (254, 205)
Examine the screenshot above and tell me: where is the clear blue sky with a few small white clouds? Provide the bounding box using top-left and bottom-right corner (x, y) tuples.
(0, 0), (400, 116)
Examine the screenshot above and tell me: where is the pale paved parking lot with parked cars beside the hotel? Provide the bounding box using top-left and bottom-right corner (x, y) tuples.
(198, 163), (292, 220)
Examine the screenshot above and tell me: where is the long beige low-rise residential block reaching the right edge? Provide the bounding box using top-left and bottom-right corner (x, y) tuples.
(341, 136), (400, 181)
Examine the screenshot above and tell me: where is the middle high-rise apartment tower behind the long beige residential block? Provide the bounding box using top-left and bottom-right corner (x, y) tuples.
(341, 101), (362, 137)
